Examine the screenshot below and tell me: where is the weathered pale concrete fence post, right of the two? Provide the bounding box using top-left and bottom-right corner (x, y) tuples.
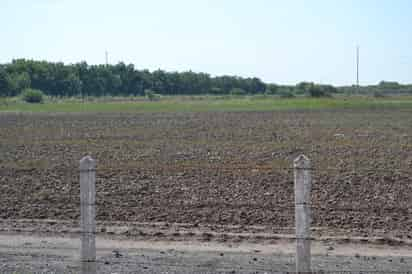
(293, 155), (312, 273)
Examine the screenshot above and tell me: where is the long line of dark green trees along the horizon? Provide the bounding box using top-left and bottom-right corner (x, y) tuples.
(0, 59), (412, 97)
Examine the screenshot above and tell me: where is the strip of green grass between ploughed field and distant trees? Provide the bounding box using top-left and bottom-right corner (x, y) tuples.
(0, 96), (412, 113)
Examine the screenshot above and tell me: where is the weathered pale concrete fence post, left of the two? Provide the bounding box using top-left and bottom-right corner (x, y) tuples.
(80, 156), (96, 274)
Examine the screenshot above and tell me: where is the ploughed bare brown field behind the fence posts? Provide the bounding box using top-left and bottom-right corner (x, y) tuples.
(0, 109), (412, 240)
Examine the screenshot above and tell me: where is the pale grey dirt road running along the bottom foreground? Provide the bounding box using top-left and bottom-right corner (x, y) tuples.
(0, 232), (412, 273)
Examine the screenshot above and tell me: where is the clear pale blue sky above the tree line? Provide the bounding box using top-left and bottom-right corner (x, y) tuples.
(0, 0), (412, 85)
